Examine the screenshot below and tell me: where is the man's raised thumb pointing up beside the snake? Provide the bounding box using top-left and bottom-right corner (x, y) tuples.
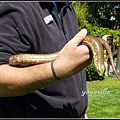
(72, 28), (87, 45)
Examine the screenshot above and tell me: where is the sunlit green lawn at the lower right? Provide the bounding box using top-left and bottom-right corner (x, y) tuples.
(86, 76), (120, 118)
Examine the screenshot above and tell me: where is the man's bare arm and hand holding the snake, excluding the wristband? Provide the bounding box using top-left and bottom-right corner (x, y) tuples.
(0, 29), (91, 97)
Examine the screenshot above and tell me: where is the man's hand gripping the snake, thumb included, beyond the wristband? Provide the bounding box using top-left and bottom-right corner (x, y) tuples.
(54, 29), (92, 78)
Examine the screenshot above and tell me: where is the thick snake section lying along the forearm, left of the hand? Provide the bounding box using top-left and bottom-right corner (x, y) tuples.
(9, 52), (59, 66)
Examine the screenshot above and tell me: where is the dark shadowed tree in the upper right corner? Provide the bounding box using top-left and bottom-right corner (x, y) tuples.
(87, 2), (120, 29)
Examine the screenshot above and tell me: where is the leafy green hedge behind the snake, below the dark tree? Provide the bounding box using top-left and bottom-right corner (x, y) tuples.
(86, 26), (120, 81)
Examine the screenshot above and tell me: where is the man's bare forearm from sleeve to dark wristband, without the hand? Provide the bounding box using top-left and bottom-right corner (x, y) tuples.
(0, 63), (56, 97)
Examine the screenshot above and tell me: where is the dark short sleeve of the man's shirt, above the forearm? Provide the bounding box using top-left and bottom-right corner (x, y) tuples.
(0, 3), (31, 65)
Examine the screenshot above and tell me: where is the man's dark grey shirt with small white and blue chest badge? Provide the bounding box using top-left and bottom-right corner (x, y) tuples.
(0, 2), (87, 118)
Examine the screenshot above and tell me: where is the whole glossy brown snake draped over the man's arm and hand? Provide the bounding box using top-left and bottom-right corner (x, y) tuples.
(9, 36), (120, 80)
